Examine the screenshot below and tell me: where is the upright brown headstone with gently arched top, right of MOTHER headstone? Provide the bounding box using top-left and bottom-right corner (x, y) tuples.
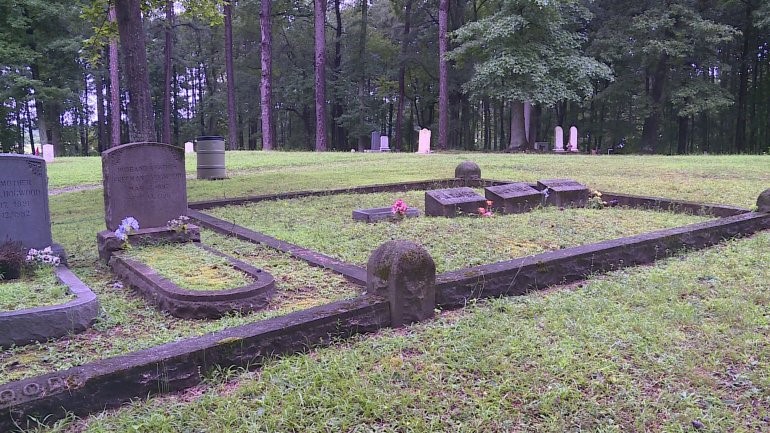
(102, 143), (187, 230)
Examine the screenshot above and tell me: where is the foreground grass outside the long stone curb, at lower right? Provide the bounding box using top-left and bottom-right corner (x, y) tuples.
(36, 232), (770, 433)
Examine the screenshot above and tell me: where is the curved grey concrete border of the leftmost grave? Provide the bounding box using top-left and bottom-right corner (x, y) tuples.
(0, 265), (100, 348)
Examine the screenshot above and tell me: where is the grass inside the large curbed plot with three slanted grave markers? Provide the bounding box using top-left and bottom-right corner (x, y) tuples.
(206, 191), (708, 272)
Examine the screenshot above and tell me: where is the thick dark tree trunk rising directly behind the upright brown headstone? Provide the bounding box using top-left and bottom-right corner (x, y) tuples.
(115, 0), (157, 141)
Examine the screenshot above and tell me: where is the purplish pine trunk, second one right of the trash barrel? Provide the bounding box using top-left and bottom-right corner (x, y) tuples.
(259, 0), (275, 150)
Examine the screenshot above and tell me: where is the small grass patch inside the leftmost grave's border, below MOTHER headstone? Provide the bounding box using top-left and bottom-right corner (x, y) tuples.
(0, 266), (74, 312)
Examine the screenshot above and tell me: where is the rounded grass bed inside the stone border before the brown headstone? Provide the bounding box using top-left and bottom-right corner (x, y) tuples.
(126, 244), (254, 290)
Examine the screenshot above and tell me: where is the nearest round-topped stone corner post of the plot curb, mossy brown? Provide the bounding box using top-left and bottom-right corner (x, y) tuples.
(366, 241), (436, 327)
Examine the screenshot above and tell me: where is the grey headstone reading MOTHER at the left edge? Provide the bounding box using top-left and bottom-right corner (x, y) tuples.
(0, 154), (53, 249)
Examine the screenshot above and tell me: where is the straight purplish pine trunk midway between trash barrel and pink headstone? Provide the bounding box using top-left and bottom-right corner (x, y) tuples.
(313, 0), (327, 152)
